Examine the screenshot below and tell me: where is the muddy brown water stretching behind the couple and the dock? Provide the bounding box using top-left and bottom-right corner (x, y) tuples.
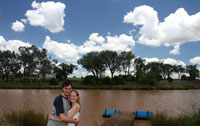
(0, 89), (200, 126)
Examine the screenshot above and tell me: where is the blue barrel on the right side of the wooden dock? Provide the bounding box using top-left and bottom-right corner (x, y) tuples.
(136, 111), (153, 119)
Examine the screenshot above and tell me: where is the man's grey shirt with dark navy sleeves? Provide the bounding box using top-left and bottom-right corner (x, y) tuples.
(47, 95), (71, 126)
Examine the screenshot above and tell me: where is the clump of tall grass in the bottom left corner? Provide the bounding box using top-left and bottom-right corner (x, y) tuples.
(0, 110), (47, 126)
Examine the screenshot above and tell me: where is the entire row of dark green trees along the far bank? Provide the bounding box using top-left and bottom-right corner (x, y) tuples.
(0, 45), (199, 84)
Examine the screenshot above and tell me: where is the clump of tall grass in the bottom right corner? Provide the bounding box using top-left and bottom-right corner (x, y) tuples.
(151, 112), (200, 126)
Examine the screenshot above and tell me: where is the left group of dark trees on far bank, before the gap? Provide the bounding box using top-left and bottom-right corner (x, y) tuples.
(0, 45), (77, 81)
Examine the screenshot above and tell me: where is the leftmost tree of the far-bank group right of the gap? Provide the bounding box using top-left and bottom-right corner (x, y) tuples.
(78, 52), (106, 78)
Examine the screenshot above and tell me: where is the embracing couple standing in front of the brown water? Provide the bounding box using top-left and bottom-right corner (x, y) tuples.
(47, 80), (80, 126)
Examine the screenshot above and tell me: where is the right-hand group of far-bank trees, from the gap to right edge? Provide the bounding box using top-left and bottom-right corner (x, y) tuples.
(78, 50), (199, 83)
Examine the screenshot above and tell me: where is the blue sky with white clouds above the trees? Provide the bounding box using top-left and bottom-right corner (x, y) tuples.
(0, 0), (200, 77)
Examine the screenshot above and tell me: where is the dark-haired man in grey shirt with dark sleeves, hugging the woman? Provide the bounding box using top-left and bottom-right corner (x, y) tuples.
(47, 80), (79, 126)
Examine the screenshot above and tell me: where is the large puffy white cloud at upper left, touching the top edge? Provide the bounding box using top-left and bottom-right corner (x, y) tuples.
(25, 1), (65, 33)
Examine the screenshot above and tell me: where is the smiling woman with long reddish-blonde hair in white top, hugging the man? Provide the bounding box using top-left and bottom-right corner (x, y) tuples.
(49, 90), (80, 126)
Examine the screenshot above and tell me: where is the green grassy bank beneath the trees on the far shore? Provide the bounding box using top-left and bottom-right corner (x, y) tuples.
(0, 79), (200, 90)
